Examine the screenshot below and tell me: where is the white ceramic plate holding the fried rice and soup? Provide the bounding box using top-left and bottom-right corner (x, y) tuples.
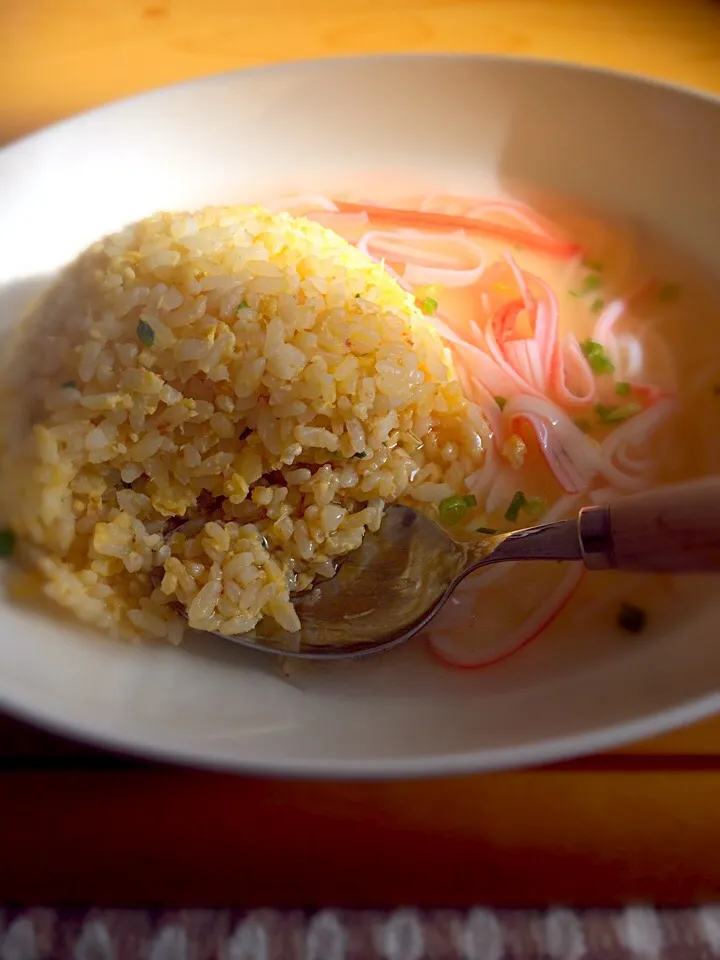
(0, 57), (720, 776)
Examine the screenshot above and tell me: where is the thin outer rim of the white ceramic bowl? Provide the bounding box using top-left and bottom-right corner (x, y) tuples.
(0, 52), (720, 781)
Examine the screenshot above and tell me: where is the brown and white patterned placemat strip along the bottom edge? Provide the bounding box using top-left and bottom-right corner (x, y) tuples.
(5, 906), (720, 960)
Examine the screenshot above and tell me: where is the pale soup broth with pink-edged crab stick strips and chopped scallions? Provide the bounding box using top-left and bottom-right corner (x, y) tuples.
(274, 191), (720, 666)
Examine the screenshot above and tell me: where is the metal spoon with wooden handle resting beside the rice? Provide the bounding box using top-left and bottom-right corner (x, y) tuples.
(190, 477), (720, 660)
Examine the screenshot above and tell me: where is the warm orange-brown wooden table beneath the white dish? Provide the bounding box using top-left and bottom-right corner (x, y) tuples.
(0, 0), (720, 907)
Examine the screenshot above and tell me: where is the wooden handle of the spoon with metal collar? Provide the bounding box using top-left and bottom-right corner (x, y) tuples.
(578, 477), (720, 573)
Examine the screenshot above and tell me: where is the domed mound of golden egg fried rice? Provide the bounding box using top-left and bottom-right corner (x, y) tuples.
(0, 207), (486, 642)
